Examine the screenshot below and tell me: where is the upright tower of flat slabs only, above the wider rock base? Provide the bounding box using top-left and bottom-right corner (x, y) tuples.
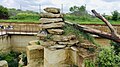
(39, 8), (65, 39)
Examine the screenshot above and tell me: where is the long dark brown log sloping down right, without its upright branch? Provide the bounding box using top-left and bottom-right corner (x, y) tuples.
(65, 22), (120, 43)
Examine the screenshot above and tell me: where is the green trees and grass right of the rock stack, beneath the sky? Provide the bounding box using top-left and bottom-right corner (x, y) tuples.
(65, 5), (120, 24)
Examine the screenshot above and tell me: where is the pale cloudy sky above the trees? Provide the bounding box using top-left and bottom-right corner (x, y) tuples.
(0, 0), (120, 15)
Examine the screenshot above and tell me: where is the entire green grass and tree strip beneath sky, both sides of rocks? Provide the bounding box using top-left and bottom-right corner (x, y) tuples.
(0, 5), (120, 24)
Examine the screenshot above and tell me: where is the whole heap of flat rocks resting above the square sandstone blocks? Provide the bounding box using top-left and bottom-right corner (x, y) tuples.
(37, 8), (79, 49)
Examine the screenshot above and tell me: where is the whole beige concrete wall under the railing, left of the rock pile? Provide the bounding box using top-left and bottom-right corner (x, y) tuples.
(0, 35), (36, 53)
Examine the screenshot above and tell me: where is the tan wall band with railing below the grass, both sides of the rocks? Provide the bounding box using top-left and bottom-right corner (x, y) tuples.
(0, 22), (120, 35)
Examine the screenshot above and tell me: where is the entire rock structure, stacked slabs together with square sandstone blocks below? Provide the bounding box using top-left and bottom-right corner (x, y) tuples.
(26, 8), (96, 67)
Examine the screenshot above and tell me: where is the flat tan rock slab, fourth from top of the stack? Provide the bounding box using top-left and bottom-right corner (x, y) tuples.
(39, 22), (65, 29)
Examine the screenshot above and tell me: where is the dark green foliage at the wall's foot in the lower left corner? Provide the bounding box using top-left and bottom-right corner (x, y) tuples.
(0, 51), (19, 67)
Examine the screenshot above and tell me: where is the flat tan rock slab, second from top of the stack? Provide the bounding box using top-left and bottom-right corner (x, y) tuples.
(40, 13), (63, 18)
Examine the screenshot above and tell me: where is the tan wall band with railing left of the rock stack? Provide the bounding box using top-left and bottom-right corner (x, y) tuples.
(0, 23), (40, 35)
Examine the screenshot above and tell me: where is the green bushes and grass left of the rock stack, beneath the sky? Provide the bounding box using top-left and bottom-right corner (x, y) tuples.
(0, 6), (40, 22)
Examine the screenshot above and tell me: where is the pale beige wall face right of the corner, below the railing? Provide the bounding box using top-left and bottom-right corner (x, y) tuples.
(10, 35), (36, 52)
